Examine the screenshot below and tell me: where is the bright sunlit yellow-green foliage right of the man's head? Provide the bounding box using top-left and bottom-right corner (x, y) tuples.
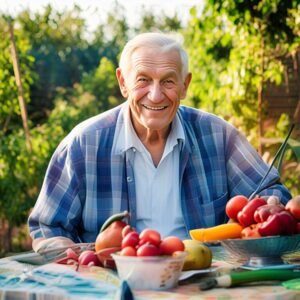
(183, 0), (299, 195)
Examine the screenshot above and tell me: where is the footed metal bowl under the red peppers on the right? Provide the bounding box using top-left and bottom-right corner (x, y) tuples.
(220, 234), (300, 267)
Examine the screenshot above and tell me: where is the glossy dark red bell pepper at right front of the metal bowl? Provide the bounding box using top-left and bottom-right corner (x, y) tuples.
(258, 211), (297, 236)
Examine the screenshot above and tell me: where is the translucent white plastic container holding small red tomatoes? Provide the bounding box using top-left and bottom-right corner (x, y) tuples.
(112, 252), (187, 290)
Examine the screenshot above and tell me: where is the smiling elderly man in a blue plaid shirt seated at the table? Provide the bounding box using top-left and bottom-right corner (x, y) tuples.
(29, 33), (291, 251)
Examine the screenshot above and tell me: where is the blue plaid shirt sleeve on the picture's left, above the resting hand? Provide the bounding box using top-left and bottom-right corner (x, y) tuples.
(28, 138), (84, 242)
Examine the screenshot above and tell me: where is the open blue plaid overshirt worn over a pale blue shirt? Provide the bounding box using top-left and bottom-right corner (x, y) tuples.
(28, 102), (291, 242)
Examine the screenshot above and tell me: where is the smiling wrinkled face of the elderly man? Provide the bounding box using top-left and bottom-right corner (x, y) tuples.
(117, 47), (191, 135)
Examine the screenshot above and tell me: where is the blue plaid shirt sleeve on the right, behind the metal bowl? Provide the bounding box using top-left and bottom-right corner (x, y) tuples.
(226, 126), (291, 203)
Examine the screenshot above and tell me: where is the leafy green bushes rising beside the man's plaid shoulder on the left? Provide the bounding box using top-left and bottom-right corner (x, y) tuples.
(0, 85), (99, 252)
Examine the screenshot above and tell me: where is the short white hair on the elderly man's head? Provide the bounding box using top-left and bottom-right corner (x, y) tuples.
(119, 32), (189, 78)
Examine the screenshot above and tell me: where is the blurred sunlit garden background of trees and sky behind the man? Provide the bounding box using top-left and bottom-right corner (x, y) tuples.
(0, 0), (300, 256)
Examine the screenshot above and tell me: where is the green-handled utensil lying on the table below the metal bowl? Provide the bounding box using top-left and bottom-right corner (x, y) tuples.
(199, 269), (300, 290)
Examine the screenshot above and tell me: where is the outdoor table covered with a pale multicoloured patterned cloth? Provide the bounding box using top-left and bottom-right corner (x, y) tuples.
(0, 247), (300, 300)
